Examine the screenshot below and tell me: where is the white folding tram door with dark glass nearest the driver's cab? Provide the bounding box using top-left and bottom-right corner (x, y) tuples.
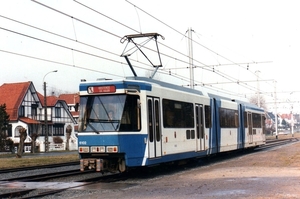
(147, 97), (162, 158)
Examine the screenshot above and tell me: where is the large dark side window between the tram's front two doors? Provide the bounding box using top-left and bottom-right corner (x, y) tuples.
(163, 99), (194, 128)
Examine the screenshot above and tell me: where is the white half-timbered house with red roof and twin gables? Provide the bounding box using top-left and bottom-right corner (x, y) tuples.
(0, 81), (77, 152)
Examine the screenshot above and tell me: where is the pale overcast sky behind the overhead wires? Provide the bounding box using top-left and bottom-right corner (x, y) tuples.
(0, 0), (300, 112)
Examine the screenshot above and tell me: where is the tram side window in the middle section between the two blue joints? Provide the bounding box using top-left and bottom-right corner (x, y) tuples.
(219, 108), (239, 128)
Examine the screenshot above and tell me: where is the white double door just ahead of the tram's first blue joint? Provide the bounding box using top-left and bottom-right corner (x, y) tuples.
(195, 104), (205, 151)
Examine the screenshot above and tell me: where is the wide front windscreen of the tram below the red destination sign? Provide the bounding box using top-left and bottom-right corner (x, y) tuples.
(78, 95), (140, 132)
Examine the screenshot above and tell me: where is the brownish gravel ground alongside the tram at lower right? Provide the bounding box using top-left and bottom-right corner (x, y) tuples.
(0, 134), (300, 199)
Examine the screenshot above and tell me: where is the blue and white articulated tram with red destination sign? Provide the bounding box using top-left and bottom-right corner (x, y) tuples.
(78, 77), (265, 172)
